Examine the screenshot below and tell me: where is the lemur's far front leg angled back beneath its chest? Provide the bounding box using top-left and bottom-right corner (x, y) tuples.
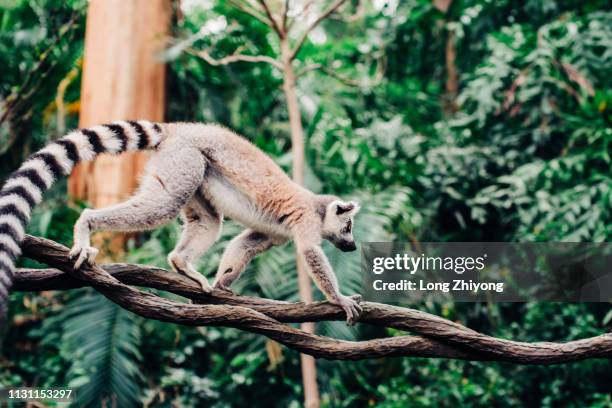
(214, 228), (286, 291)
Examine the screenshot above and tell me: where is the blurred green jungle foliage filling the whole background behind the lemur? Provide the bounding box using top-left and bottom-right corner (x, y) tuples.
(0, 0), (612, 407)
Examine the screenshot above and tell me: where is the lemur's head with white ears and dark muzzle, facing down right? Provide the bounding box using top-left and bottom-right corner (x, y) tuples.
(321, 199), (359, 252)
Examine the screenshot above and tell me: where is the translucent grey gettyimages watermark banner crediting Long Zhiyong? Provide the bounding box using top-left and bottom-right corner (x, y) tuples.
(361, 242), (612, 303)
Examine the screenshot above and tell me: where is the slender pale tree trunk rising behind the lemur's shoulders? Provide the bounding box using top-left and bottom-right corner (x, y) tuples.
(281, 37), (320, 408)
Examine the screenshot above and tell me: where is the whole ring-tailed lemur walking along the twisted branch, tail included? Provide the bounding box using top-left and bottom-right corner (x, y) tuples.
(0, 120), (361, 323)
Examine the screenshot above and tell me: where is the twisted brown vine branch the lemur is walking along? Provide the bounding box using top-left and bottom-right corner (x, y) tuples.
(14, 236), (612, 364)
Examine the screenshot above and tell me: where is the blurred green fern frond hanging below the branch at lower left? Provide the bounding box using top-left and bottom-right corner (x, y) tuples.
(49, 289), (144, 407)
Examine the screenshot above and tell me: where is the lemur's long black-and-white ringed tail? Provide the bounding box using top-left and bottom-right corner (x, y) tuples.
(0, 120), (163, 328)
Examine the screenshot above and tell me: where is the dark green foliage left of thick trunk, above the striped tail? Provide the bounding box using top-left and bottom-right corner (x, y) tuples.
(0, 0), (86, 174)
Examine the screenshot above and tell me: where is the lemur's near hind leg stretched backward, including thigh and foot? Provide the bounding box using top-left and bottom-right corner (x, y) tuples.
(70, 146), (205, 268)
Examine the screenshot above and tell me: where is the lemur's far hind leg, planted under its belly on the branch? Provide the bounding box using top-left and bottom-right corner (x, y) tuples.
(168, 192), (223, 292)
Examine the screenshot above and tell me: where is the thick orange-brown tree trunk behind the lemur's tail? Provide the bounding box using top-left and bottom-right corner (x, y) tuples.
(68, 0), (171, 249)
